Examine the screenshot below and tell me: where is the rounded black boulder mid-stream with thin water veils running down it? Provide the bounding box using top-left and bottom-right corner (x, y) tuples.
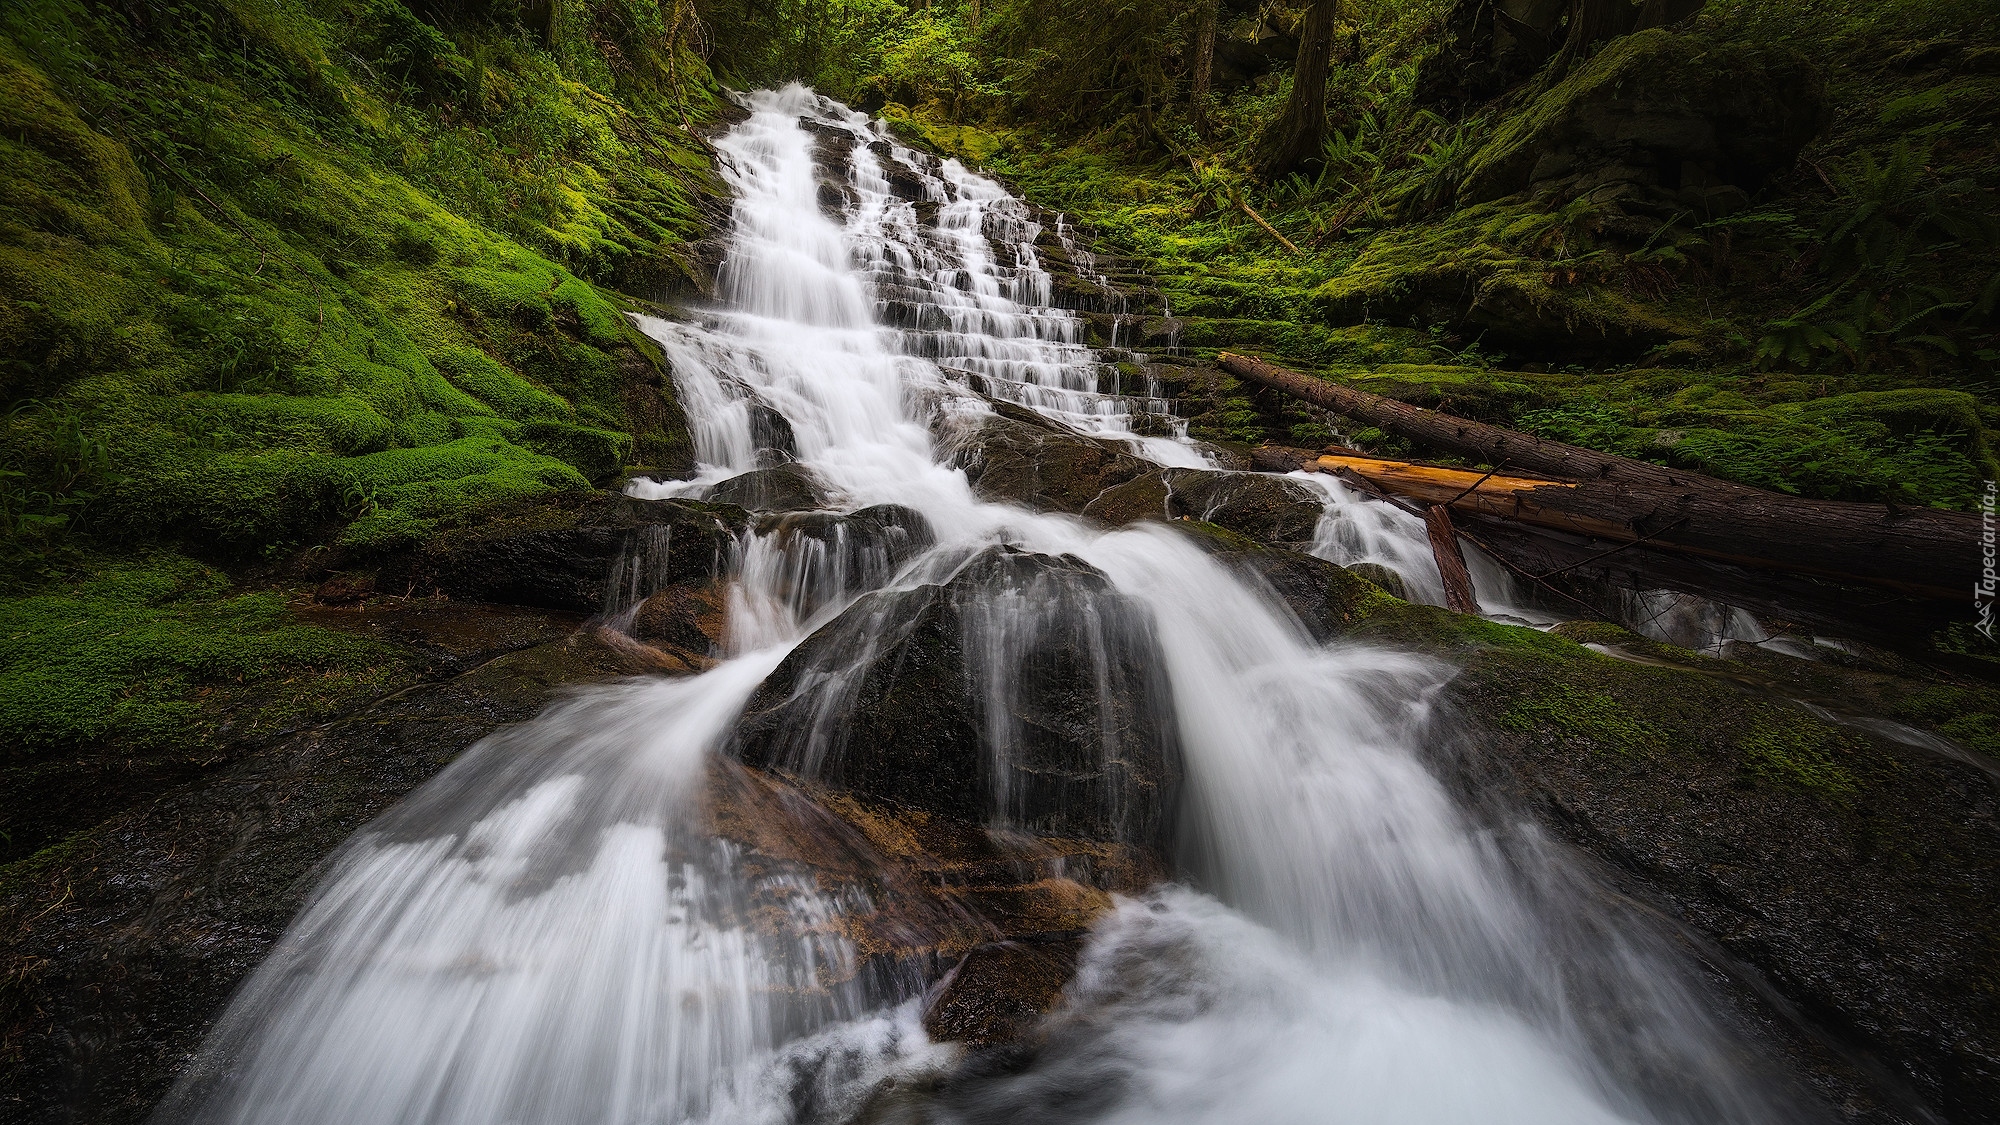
(734, 546), (1180, 843)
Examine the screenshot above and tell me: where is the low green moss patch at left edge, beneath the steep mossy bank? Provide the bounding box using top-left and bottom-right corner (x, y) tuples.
(0, 554), (410, 857)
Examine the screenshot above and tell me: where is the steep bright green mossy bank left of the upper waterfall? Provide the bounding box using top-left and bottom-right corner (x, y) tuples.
(0, 0), (718, 589)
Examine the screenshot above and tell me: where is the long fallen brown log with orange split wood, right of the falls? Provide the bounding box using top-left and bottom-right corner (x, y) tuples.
(1220, 352), (1980, 613)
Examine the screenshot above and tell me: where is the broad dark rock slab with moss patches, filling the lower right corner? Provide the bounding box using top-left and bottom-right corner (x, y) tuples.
(1446, 625), (2000, 1125)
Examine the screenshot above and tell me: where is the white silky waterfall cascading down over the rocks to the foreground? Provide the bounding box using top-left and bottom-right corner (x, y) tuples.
(162, 86), (1784, 1125)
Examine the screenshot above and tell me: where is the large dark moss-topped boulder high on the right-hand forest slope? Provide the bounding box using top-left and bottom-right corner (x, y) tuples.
(1460, 28), (1828, 210)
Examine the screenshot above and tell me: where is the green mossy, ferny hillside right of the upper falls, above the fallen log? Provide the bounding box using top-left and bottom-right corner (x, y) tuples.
(864, 0), (2000, 508)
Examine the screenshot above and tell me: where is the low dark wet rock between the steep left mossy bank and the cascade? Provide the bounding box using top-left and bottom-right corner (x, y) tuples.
(378, 492), (748, 613)
